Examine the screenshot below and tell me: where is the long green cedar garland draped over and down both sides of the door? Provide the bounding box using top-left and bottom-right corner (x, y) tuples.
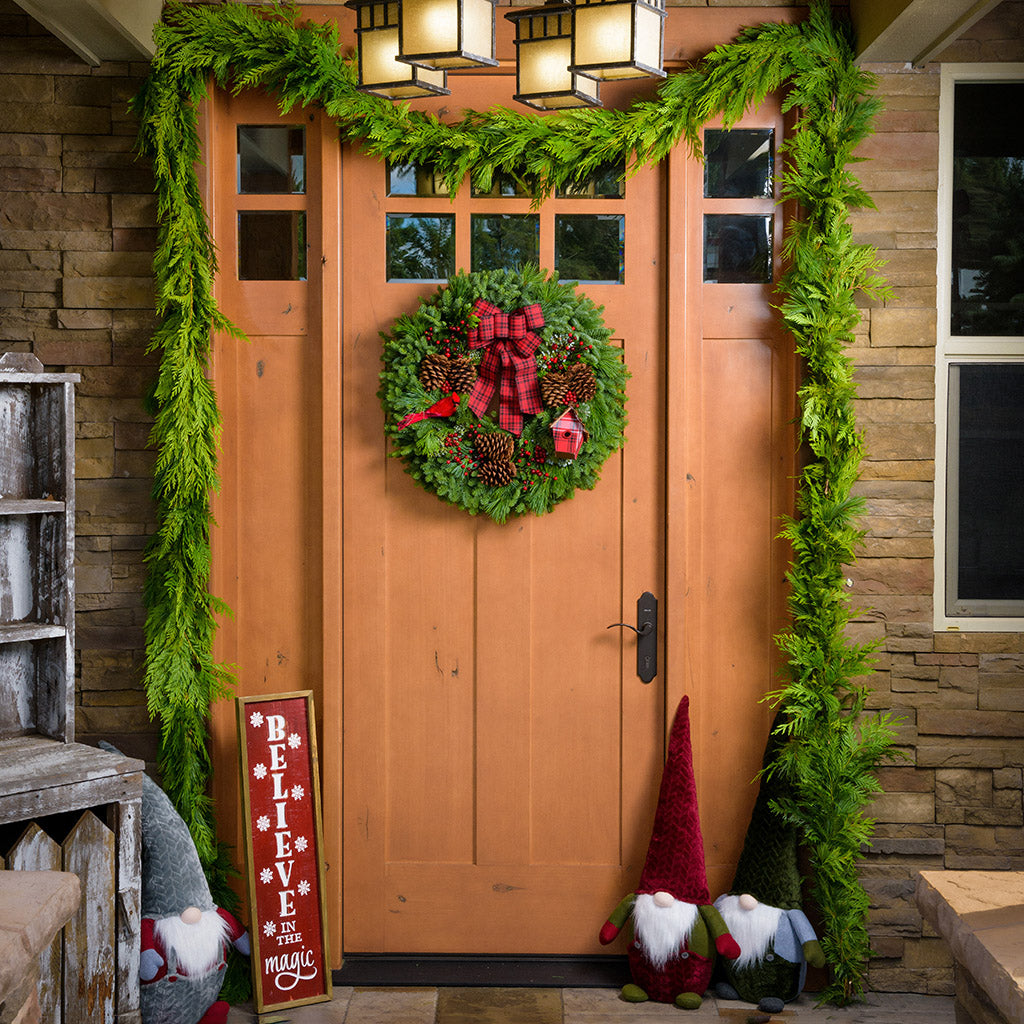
(134, 0), (893, 1002)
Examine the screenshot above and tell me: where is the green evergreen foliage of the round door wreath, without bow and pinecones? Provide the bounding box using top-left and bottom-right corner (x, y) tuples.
(378, 266), (629, 522)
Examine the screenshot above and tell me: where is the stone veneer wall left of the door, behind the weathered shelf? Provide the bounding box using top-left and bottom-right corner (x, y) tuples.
(0, 0), (157, 762)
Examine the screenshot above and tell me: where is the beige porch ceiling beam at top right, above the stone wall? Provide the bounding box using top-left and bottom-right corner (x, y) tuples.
(850, 0), (999, 66)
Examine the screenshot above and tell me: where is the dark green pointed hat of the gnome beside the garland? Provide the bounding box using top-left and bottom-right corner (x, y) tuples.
(731, 713), (802, 910)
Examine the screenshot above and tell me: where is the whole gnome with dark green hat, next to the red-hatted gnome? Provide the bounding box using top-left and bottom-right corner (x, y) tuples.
(715, 718), (825, 1014)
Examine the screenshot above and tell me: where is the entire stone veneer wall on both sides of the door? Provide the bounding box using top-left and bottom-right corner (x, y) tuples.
(0, 0), (1024, 992)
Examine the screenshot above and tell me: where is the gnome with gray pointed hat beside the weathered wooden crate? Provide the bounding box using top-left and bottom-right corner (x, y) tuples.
(139, 775), (249, 1024)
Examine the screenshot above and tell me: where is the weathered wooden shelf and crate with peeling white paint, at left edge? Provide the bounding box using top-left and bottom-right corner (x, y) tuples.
(0, 353), (143, 1024)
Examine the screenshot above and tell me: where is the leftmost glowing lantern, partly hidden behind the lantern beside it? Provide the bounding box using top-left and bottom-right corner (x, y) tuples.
(345, 0), (450, 99)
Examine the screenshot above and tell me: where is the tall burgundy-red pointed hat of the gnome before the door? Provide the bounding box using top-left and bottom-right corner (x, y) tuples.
(637, 696), (711, 904)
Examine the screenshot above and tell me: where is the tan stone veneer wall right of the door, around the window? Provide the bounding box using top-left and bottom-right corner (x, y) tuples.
(849, 0), (1024, 993)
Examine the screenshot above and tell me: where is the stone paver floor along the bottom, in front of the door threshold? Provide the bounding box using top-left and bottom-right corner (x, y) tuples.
(227, 987), (955, 1024)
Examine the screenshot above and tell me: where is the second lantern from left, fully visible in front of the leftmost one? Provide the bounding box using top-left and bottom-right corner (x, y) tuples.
(398, 0), (498, 71)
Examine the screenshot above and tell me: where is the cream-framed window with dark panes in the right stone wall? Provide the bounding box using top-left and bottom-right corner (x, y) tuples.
(935, 65), (1024, 631)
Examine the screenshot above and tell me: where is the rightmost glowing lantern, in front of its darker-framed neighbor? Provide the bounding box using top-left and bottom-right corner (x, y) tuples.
(569, 0), (665, 81)
